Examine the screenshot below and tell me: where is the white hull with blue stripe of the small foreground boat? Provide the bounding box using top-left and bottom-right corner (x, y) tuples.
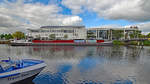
(0, 63), (46, 84)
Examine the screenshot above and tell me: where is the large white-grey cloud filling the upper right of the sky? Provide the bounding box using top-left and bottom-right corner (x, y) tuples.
(62, 0), (150, 21)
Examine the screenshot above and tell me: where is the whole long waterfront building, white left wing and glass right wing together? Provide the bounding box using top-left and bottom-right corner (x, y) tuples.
(28, 26), (140, 40)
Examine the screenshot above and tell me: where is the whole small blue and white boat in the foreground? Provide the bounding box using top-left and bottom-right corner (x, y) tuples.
(0, 58), (46, 84)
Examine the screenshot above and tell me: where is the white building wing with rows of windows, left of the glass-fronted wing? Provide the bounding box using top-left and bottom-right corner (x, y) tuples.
(28, 26), (87, 39)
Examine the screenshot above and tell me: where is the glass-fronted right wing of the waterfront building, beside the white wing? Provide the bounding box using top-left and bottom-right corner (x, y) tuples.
(87, 26), (141, 40)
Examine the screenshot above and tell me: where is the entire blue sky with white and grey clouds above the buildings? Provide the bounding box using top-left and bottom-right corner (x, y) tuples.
(0, 0), (150, 33)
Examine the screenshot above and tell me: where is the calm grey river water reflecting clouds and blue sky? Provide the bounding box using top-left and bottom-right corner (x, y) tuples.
(0, 45), (150, 84)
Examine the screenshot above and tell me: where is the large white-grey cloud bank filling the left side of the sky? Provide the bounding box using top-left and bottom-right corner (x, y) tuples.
(0, 0), (82, 32)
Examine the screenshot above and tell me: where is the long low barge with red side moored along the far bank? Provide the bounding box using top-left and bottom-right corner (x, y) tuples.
(10, 40), (112, 46)
